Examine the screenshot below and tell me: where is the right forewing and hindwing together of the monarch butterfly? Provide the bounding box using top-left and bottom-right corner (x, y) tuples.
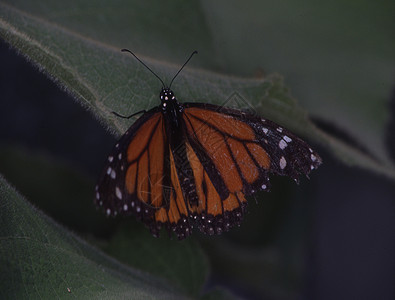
(179, 103), (321, 234)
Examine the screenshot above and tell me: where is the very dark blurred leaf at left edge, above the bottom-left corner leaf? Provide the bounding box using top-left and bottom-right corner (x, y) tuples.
(0, 145), (110, 235)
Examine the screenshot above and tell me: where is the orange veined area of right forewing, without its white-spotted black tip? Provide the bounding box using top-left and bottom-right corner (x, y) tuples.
(185, 105), (271, 194)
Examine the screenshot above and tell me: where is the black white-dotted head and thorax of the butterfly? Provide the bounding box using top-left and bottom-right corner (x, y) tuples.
(159, 88), (184, 128)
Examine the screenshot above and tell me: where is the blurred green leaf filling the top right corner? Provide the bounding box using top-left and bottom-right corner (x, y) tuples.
(203, 0), (395, 166)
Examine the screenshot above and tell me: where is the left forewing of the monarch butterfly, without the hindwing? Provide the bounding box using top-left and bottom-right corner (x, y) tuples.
(95, 108), (168, 223)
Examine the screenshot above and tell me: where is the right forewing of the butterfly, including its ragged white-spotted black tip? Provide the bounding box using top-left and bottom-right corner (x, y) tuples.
(185, 103), (321, 184)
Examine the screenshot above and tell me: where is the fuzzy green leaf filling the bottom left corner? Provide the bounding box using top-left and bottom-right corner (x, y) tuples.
(0, 175), (188, 299)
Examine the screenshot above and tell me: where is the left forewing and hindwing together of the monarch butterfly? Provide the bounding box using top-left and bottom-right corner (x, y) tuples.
(95, 108), (195, 238)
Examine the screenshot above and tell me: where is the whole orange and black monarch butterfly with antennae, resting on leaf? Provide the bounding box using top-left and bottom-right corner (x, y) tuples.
(95, 49), (321, 239)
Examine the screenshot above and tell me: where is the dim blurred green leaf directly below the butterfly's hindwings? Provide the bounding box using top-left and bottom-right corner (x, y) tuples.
(104, 224), (209, 296)
